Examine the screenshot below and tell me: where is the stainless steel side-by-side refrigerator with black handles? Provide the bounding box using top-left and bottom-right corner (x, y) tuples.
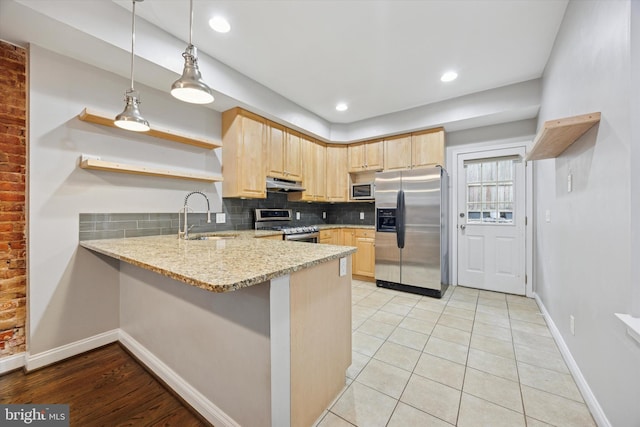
(375, 166), (449, 298)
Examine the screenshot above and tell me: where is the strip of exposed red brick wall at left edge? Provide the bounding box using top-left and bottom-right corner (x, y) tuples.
(0, 41), (27, 358)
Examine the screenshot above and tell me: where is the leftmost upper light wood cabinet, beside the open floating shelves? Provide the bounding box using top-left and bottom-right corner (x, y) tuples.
(222, 108), (267, 199)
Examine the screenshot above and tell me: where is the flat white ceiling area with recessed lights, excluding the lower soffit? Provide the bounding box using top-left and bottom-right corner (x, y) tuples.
(127, 0), (567, 123)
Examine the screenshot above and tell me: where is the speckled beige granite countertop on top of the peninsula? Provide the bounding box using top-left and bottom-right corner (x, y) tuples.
(80, 230), (356, 292)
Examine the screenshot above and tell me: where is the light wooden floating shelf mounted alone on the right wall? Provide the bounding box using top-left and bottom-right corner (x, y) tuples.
(525, 112), (600, 160)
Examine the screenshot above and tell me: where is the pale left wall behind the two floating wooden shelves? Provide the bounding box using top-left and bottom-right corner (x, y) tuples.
(27, 45), (221, 355)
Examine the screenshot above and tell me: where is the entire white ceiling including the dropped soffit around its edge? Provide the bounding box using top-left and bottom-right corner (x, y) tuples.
(0, 0), (568, 142)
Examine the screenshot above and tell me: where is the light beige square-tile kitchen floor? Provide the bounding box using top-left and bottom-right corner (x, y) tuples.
(317, 280), (595, 427)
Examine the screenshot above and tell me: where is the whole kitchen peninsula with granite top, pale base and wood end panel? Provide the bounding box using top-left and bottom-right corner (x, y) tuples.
(80, 234), (355, 427)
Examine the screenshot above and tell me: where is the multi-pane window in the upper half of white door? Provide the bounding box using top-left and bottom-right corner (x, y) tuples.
(464, 158), (516, 224)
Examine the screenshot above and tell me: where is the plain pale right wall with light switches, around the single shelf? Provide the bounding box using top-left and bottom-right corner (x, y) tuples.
(534, 0), (640, 426)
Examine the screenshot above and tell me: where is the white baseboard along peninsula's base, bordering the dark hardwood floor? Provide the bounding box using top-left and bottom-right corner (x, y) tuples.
(119, 330), (240, 427)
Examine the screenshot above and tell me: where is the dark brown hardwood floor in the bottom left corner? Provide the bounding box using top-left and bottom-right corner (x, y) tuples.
(0, 344), (209, 427)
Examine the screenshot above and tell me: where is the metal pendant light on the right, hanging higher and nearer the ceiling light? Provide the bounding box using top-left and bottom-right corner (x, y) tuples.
(171, 0), (213, 104)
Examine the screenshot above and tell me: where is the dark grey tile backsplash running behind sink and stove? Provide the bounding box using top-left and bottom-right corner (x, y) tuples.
(80, 193), (375, 240)
